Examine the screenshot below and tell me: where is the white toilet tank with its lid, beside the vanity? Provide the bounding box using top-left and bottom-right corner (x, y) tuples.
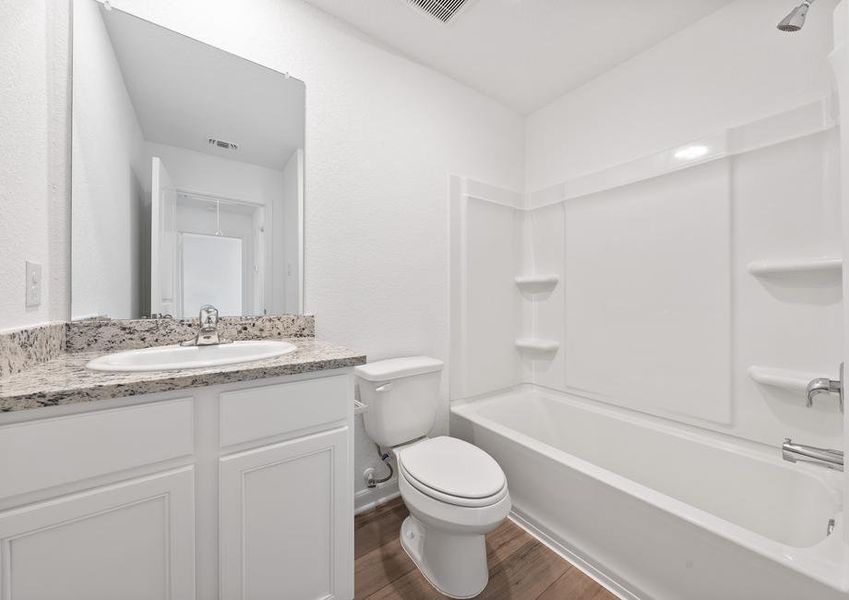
(354, 356), (443, 448)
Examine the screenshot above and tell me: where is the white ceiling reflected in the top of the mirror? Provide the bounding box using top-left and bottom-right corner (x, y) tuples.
(101, 9), (305, 170)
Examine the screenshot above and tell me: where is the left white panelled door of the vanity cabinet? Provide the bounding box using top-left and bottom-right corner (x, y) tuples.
(0, 467), (195, 600)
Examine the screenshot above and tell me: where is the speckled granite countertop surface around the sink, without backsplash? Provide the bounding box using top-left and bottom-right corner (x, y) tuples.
(0, 337), (366, 412)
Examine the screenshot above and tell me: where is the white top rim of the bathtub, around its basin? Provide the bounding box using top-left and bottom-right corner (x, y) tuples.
(450, 384), (849, 592)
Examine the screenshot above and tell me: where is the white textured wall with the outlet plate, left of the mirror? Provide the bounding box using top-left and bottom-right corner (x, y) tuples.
(0, 0), (70, 330)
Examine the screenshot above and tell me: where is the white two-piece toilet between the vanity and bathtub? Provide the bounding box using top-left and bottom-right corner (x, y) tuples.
(355, 356), (511, 598)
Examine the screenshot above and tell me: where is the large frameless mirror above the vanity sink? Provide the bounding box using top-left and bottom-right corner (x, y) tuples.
(71, 0), (305, 319)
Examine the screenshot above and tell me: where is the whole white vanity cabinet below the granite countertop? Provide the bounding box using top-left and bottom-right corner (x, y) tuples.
(0, 369), (354, 600)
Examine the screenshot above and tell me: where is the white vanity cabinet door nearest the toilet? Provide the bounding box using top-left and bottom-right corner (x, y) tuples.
(220, 427), (354, 600)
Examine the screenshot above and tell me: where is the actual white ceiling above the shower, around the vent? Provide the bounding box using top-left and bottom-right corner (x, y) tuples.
(306, 0), (731, 113)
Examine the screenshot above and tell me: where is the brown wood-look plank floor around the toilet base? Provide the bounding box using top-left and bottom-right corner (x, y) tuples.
(354, 498), (616, 600)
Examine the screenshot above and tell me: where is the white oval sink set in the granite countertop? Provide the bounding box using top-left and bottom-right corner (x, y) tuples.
(86, 340), (296, 371)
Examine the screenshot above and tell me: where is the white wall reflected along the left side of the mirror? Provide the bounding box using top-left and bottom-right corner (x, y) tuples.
(71, 2), (150, 318)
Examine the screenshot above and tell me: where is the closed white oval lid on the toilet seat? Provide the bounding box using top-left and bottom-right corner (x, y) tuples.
(398, 437), (507, 498)
